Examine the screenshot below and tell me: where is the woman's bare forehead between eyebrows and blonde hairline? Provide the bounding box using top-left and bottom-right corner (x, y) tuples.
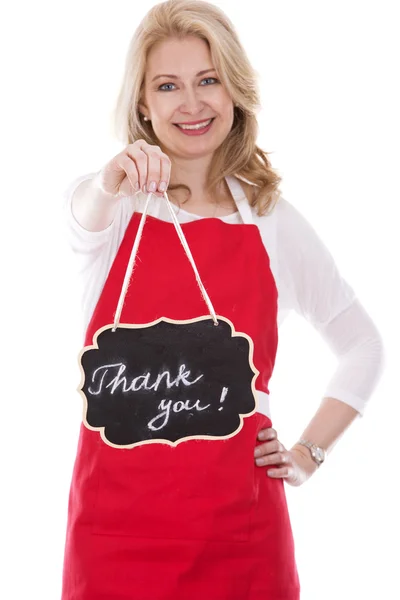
(146, 36), (214, 77)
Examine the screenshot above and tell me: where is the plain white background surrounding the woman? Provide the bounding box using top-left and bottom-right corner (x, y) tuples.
(0, 0), (400, 600)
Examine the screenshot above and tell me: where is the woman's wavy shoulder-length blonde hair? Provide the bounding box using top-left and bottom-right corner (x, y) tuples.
(114, 0), (281, 215)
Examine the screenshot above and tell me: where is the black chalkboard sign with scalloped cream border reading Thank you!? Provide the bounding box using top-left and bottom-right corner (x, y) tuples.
(79, 316), (258, 448)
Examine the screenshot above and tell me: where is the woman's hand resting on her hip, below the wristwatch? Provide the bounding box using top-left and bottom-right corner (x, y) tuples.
(254, 428), (318, 486)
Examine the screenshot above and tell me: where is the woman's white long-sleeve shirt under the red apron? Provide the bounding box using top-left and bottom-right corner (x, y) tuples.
(64, 173), (384, 415)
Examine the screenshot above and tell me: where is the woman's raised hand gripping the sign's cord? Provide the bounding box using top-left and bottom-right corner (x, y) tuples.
(94, 140), (171, 198)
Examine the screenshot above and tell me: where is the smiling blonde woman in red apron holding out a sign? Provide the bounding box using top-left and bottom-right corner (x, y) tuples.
(62, 0), (383, 600)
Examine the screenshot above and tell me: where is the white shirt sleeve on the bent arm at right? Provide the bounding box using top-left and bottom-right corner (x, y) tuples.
(276, 197), (385, 415)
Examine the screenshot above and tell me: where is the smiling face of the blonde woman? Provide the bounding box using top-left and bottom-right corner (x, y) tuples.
(139, 36), (234, 158)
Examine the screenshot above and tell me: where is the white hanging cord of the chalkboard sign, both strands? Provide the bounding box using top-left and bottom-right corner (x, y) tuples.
(112, 192), (218, 332)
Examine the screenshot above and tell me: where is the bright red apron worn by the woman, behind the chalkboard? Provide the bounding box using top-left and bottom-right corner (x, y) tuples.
(62, 195), (299, 600)
